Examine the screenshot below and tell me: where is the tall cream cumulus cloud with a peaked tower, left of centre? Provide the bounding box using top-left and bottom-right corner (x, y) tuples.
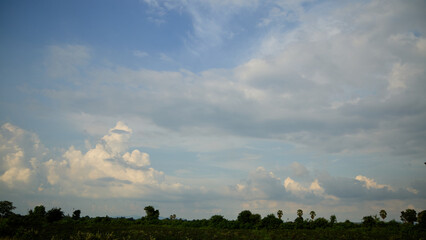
(45, 122), (175, 197)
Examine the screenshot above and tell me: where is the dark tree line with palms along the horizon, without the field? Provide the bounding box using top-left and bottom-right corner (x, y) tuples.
(0, 201), (426, 237)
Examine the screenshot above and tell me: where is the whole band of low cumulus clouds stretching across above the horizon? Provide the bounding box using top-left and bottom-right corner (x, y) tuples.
(0, 122), (426, 220)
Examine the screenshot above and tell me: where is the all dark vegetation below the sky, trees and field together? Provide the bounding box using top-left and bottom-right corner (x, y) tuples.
(0, 201), (426, 240)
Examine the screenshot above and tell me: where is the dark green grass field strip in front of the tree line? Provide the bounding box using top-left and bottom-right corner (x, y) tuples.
(0, 223), (426, 240)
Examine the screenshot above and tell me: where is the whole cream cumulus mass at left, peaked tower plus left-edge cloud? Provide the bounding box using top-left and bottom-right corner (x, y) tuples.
(0, 122), (190, 198)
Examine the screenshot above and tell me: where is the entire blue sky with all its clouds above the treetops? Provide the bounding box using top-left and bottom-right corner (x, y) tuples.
(0, 0), (426, 221)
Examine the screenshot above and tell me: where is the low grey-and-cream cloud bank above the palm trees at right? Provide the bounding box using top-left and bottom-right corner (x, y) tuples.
(229, 163), (423, 206)
